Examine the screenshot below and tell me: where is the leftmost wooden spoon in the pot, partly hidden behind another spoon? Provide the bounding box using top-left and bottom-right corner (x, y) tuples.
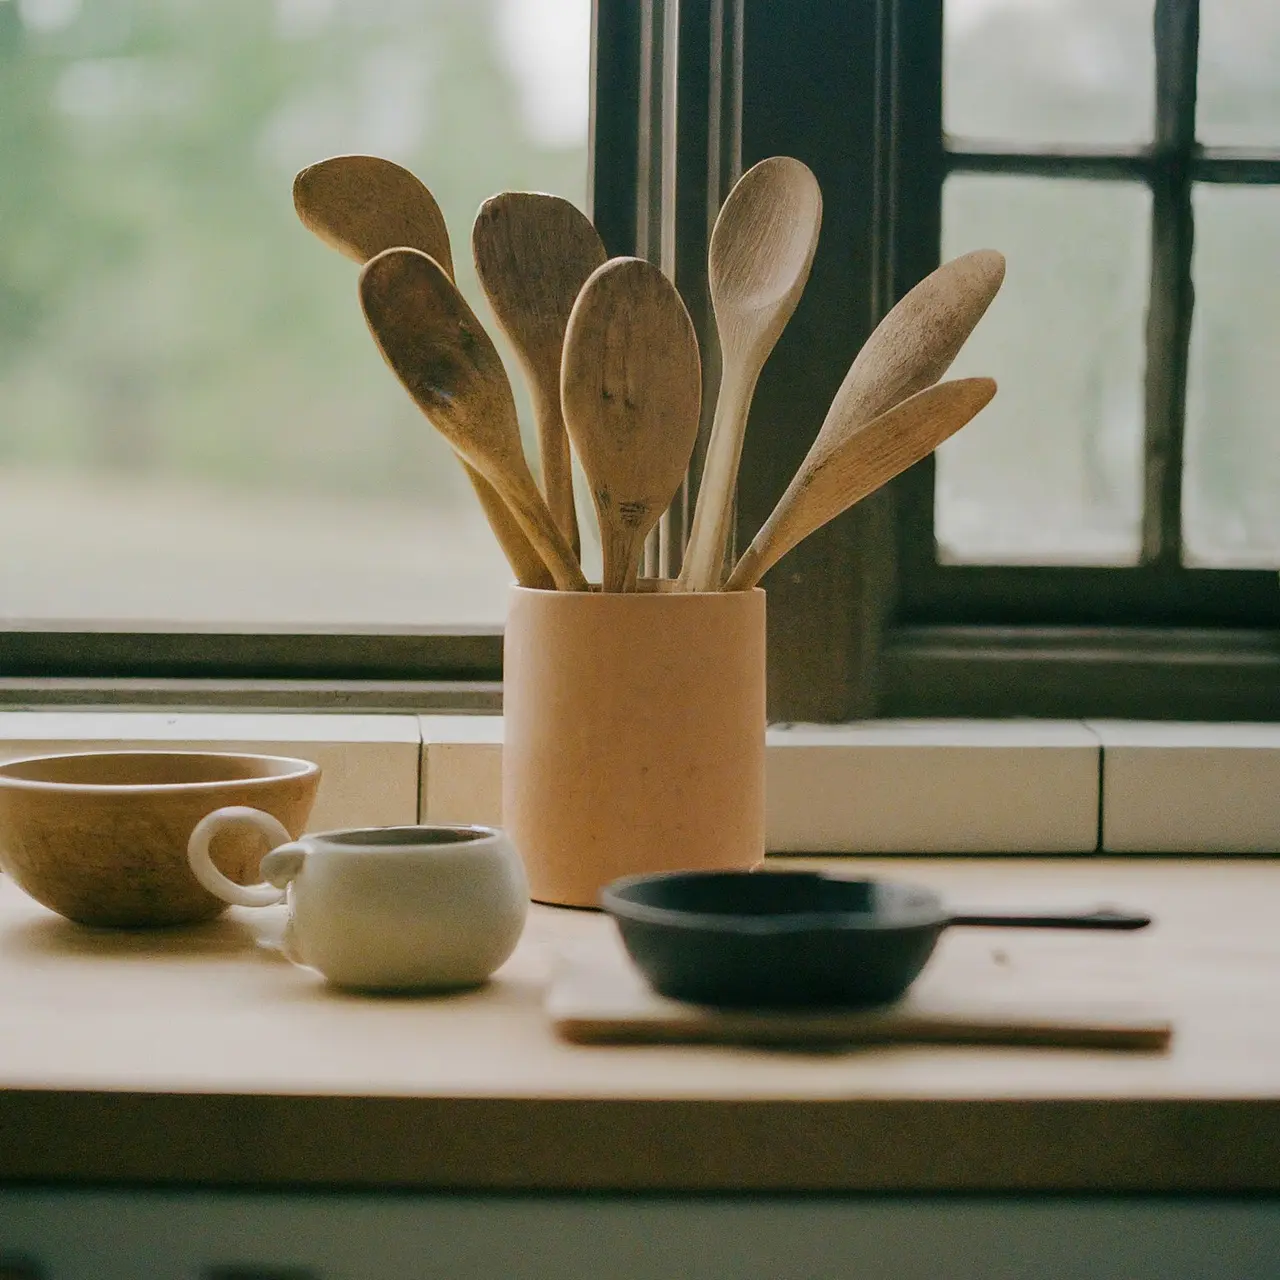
(293, 156), (552, 588)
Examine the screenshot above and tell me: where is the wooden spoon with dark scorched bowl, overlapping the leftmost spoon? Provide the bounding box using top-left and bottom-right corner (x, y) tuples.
(360, 248), (586, 591)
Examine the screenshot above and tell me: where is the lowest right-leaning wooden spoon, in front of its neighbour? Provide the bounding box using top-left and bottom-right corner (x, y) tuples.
(724, 378), (996, 591)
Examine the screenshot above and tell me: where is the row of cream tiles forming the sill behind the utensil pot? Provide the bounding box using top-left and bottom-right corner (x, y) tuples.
(0, 708), (1280, 854)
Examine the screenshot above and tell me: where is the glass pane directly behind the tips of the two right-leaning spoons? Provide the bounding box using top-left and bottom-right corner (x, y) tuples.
(936, 177), (1149, 564)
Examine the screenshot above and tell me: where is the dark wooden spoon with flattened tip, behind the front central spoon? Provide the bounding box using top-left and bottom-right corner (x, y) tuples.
(471, 191), (607, 554)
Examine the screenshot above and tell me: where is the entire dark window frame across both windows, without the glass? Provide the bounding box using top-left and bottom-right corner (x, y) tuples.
(0, 0), (1280, 721)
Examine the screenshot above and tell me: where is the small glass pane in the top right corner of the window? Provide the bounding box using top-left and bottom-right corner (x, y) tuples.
(1196, 0), (1280, 147)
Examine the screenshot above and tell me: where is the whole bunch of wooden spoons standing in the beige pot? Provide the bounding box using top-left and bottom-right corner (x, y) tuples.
(293, 156), (1005, 591)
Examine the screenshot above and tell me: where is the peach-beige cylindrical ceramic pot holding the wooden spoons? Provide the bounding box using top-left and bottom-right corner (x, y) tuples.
(502, 584), (765, 906)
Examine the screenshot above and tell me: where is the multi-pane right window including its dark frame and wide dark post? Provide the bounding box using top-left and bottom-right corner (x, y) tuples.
(670, 0), (1280, 719)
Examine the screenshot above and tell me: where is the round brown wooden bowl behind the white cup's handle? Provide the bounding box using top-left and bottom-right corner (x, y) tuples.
(0, 751), (320, 927)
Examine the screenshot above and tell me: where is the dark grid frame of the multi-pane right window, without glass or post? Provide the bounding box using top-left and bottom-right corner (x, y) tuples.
(886, 0), (1280, 719)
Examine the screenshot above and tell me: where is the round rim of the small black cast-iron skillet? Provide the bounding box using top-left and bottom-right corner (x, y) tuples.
(600, 868), (948, 937)
